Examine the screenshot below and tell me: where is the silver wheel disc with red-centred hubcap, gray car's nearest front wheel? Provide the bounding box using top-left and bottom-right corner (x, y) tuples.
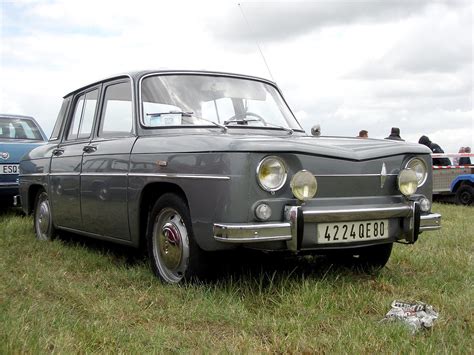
(153, 208), (189, 283)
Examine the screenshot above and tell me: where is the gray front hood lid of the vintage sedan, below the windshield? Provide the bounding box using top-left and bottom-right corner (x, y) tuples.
(134, 133), (431, 160)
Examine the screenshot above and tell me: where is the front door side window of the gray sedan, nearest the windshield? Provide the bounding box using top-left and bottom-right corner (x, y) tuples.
(99, 81), (133, 137)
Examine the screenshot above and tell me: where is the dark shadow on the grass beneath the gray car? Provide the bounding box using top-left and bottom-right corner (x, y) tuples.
(52, 232), (377, 285)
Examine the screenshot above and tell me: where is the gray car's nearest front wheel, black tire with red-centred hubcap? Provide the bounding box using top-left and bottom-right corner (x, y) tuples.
(147, 193), (208, 284)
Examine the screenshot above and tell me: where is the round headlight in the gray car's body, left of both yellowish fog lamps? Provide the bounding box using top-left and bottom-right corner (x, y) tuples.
(257, 156), (286, 191)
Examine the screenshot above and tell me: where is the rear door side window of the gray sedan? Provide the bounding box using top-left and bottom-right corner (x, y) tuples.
(67, 89), (99, 140)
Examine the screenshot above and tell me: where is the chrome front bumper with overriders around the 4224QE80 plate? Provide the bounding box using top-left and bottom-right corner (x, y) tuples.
(214, 202), (441, 251)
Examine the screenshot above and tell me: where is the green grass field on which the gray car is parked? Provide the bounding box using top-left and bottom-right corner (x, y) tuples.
(0, 204), (474, 354)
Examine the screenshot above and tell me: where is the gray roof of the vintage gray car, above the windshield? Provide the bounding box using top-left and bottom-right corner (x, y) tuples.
(64, 69), (276, 98)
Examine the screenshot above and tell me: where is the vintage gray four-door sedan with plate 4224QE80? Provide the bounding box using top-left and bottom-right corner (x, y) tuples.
(20, 71), (441, 283)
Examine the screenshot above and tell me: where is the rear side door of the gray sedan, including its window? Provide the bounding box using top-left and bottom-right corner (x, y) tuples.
(50, 86), (100, 230)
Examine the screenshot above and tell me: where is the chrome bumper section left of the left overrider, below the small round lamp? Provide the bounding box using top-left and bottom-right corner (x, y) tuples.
(213, 222), (291, 243)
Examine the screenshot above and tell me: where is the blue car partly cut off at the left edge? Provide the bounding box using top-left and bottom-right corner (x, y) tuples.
(0, 114), (46, 206)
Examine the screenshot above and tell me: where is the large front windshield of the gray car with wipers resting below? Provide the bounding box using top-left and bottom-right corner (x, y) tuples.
(141, 75), (301, 130)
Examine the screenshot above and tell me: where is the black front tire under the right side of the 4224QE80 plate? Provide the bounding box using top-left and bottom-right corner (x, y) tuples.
(331, 243), (393, 272)
